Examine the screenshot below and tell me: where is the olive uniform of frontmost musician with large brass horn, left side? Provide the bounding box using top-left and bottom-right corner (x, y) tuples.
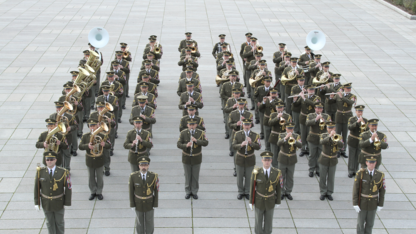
(79, 132), (111, 194)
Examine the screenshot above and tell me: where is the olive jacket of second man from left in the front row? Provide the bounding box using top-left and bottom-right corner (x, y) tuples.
(129, 171), (159, 212)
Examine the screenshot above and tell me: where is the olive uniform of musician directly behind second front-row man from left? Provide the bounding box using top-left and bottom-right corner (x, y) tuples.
(123, 129), (153, 172)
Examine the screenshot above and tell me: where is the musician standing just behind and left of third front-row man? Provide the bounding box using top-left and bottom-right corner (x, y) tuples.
(230, 119), (261, 200)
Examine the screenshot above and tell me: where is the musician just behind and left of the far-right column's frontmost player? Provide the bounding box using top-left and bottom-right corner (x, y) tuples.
(348, 105), (368, 178)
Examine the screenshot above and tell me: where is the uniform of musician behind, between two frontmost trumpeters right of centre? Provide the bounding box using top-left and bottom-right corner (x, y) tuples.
(306, 113), (331, 173)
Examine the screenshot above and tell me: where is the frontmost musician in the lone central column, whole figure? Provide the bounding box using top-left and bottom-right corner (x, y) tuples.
(177, 119), (208, 199)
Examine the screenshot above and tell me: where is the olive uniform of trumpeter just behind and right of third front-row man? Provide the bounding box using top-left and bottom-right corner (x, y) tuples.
(273, 133), (302, 195)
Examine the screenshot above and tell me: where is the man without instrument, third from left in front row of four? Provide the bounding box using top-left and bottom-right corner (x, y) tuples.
(249, 151), (283, 234)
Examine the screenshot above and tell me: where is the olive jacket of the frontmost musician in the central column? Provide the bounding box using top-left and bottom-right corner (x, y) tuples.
(177, 128), (208, 165)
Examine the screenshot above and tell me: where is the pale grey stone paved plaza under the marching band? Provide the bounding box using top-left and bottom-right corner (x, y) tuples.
(0, 0), (416, 234)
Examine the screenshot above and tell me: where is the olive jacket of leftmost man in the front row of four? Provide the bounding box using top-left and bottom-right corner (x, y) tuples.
(34, 166), (72, 211)
